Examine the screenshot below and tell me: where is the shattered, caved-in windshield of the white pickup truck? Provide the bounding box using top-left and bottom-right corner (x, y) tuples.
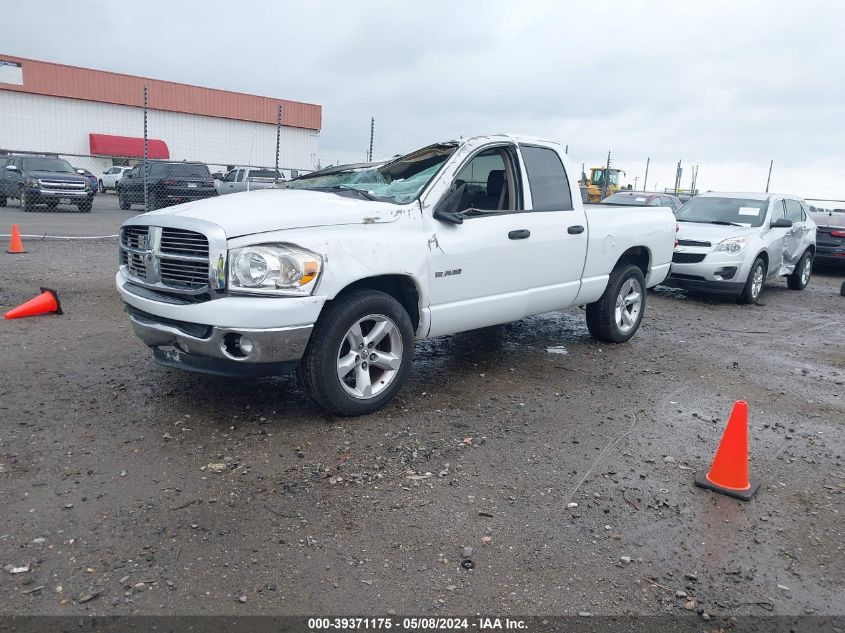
(287, 143), (457, 204)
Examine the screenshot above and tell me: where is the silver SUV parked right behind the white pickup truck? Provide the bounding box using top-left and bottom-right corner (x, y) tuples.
(666, 193), (816, 303)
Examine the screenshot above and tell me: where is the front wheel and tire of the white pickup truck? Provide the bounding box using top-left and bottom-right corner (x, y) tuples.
(299, 290), (414, 416)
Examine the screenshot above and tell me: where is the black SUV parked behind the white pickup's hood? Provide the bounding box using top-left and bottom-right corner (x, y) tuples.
(117, 160), (217, 211)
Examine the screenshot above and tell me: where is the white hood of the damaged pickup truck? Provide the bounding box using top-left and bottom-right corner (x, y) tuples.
(144, 189), (406, 238)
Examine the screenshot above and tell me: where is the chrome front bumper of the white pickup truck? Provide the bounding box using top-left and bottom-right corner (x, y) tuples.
(127, 309), (314, 366)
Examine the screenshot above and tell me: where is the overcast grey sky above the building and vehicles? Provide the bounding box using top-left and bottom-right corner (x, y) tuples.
(6, 0), (845, 199)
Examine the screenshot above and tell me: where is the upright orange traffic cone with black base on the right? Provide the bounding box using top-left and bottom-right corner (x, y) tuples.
(695, 400), (760, 501)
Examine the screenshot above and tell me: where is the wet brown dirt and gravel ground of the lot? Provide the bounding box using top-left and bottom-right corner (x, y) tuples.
(0, 200), (845, 620)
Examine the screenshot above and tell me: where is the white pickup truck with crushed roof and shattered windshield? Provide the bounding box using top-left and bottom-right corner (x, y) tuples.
(116, 135), (676, 415)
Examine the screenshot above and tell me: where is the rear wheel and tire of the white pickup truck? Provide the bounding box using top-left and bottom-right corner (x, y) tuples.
(587, 264), (646, 343)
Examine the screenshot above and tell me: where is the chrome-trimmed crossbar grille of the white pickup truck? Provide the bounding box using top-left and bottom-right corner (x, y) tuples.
(120, 225), (209, 300)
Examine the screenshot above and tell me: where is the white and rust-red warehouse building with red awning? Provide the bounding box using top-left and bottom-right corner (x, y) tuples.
(0, 53), (322, 176)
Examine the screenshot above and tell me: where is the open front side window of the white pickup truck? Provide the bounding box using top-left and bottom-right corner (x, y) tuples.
(455, 147), (516, 211)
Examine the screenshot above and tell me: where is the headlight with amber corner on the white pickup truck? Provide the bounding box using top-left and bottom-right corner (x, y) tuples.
(229, 244), (323, 297)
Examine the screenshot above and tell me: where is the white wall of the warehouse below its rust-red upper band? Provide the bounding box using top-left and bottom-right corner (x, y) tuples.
(0, 90), (319, 173)
